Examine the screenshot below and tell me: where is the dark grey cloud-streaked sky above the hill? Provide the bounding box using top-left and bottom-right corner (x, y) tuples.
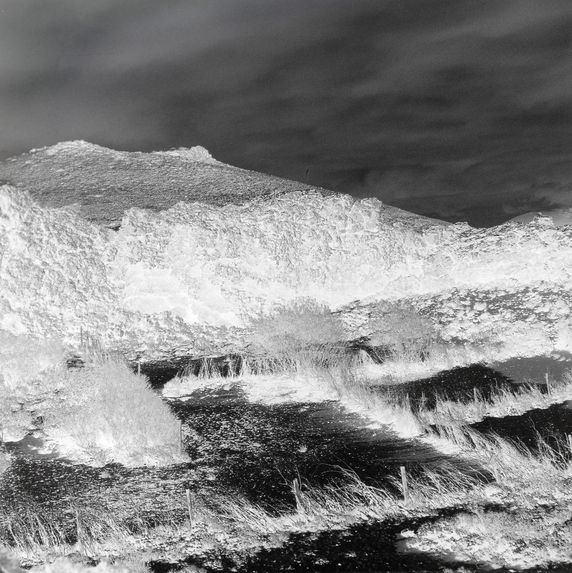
(0, 0), (572, 226)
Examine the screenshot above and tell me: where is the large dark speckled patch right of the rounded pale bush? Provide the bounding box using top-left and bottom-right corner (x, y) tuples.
(172, 388), (482, 507)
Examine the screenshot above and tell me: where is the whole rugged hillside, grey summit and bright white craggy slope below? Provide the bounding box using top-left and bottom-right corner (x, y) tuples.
(0, 142), (572, 356)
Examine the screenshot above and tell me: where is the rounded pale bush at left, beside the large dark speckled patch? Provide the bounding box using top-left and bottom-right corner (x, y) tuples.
(45, 359), (182, 465)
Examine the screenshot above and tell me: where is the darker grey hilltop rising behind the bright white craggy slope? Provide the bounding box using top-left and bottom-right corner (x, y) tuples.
(0, 140), (445, 228)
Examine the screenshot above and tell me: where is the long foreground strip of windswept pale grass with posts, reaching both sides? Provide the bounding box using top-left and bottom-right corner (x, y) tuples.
(0, 416), (572, 563)
